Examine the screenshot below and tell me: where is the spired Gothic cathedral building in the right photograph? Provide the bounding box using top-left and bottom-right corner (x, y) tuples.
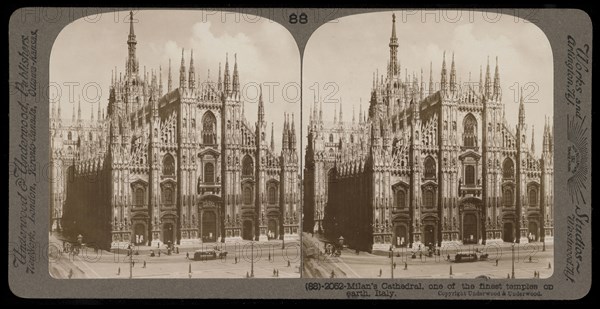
(303, 16), (554, 251)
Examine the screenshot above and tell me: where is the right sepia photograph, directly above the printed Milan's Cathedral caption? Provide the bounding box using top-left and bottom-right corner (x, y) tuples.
(302, 10), (554, 279)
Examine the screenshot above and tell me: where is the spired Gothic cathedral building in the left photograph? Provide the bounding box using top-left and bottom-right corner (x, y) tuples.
(50, 12), (300, 248)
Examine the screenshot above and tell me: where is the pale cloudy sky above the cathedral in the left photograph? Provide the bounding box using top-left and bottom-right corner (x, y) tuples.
(50, 10), (300, 150)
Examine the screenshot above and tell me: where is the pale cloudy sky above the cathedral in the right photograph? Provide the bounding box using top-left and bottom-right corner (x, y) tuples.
(303, 11), (553, 156)
